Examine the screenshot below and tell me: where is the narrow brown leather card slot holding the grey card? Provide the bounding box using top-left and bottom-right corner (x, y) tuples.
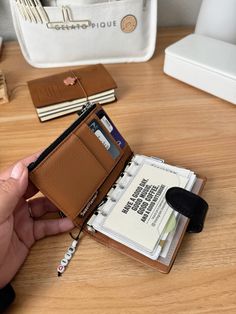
(74, 119), (123, 173)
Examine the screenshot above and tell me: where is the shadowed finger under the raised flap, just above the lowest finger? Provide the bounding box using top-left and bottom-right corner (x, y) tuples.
(28, 197), (58, 218)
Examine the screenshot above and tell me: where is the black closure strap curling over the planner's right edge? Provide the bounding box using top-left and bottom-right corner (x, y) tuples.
(166, 187), (208, 233)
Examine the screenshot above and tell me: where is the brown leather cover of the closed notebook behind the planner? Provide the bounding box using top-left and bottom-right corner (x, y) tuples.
(28, 64), (117, 108)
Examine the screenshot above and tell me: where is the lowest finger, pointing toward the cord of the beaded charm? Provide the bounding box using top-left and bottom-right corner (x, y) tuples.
(34, 218), (74, 241)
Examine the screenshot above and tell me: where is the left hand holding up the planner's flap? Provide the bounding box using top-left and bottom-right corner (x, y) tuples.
(0, 155), (74, 289)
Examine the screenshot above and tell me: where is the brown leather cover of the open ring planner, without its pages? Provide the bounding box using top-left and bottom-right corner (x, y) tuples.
(29, 104), (205, 273)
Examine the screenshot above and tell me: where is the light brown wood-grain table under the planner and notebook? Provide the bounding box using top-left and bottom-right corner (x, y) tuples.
(0, 28), (236, 314)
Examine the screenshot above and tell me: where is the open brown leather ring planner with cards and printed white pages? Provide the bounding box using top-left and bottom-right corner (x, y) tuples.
(29, 104), (206, 273)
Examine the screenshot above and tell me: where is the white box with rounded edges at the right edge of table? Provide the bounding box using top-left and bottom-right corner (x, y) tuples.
(164, 34), (236, 104)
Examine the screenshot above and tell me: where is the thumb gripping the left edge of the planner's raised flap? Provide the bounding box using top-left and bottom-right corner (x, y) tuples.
(0, 162), (28, 223)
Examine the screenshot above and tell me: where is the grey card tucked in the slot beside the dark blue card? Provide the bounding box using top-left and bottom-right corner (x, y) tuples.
(89, 120), (120, 159)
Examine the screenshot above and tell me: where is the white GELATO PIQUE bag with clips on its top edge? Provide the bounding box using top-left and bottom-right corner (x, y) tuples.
(10, 0), (157, 67)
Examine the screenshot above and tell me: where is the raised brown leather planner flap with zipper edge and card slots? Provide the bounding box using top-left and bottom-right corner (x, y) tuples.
(30, 105), (132, 220)
